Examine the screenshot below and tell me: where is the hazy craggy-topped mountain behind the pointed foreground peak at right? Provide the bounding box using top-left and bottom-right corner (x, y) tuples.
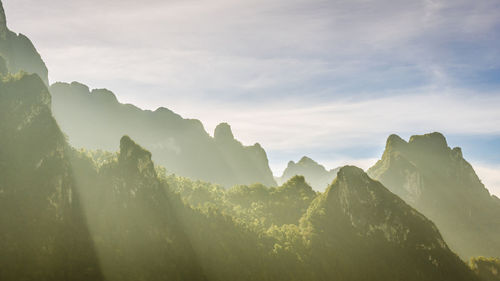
(368, 133), (500, 259)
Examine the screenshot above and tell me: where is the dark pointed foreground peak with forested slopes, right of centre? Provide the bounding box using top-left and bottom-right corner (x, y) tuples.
(302, 166), (476, 281)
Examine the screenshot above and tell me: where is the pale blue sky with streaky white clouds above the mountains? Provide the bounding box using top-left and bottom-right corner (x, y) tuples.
(3, 0), (500, 196)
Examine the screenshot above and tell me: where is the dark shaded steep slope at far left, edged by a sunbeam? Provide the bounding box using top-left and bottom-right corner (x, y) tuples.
(0, 72), (102, 280)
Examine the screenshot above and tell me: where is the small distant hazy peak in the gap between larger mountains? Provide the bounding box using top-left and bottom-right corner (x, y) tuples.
(276, 156), (339, 191)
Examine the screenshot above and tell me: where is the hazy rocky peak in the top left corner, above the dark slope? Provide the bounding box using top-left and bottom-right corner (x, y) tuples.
(0, 1), (49, 85)
